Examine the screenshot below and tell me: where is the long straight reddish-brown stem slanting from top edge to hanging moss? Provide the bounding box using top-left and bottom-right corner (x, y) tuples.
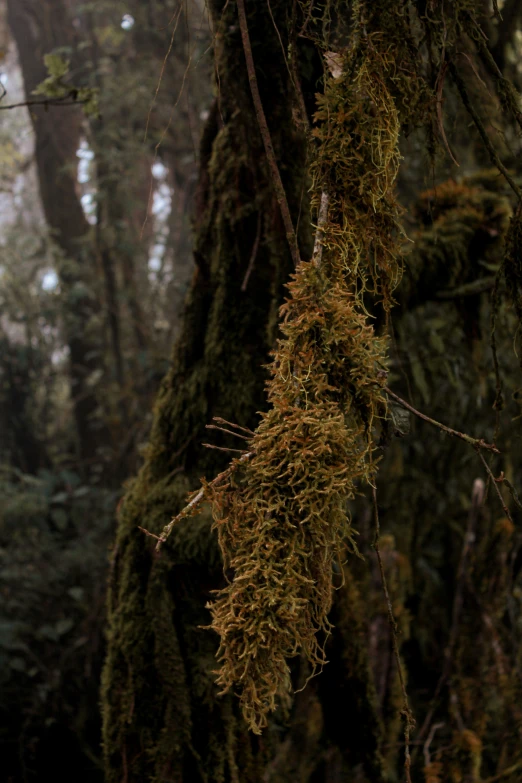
(237, 0), (300, 267)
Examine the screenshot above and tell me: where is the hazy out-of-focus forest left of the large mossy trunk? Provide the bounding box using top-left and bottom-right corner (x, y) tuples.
(0, 1), (210, 781)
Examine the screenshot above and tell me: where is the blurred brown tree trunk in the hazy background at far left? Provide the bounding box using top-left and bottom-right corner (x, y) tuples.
(8, 0), (103, 461)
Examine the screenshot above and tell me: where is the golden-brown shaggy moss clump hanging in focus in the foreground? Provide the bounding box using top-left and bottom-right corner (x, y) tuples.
(207, 35), (400, 733)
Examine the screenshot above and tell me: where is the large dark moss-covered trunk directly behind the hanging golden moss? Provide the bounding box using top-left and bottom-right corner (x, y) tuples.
(102, 0), (381, 783)
